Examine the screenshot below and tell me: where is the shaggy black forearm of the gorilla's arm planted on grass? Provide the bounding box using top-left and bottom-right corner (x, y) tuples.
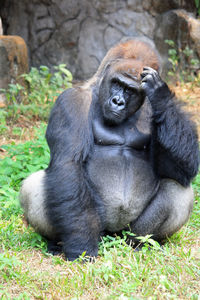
(45, 162), (101, 260)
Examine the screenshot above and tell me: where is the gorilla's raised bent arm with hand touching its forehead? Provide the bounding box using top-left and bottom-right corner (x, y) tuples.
(141, 68), (199, 186)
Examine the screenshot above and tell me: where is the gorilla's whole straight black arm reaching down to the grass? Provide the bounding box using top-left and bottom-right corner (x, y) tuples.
(45, 89), (100, 260)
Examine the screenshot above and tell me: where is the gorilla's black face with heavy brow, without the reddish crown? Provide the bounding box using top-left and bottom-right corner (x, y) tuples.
(99, 74), (144, 125)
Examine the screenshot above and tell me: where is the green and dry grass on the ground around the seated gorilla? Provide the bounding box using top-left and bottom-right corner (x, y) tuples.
(0, 124), (200, 300)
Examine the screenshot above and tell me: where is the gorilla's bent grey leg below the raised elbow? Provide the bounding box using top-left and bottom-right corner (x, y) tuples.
(130, 179), (194, 241)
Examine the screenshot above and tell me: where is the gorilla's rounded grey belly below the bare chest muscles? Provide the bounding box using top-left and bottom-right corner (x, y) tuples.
(87, 145), (157, 231)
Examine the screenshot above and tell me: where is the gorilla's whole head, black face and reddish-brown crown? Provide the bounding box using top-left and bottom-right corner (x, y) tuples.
(92, 39), (160, 125)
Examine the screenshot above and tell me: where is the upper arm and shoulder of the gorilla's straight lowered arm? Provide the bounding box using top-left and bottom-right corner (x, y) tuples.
(46, 88), (91, 166)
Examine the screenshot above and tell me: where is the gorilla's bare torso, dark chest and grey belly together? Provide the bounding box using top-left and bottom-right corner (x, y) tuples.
(87, 101), (158, 231)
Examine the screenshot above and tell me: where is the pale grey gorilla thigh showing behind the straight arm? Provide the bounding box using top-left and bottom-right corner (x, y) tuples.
(20, 170), (53, 238)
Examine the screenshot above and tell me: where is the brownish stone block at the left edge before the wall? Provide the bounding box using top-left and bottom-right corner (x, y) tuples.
(0, 35), (28, 100)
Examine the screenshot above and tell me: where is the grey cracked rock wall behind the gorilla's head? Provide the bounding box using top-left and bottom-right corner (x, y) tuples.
(0, 0), (200, 79)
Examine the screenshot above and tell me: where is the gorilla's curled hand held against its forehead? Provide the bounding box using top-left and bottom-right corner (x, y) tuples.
(141, 67), (169, 104)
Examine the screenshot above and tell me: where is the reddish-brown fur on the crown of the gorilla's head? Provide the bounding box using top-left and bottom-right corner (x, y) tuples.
(96, 39), (160, 80)
